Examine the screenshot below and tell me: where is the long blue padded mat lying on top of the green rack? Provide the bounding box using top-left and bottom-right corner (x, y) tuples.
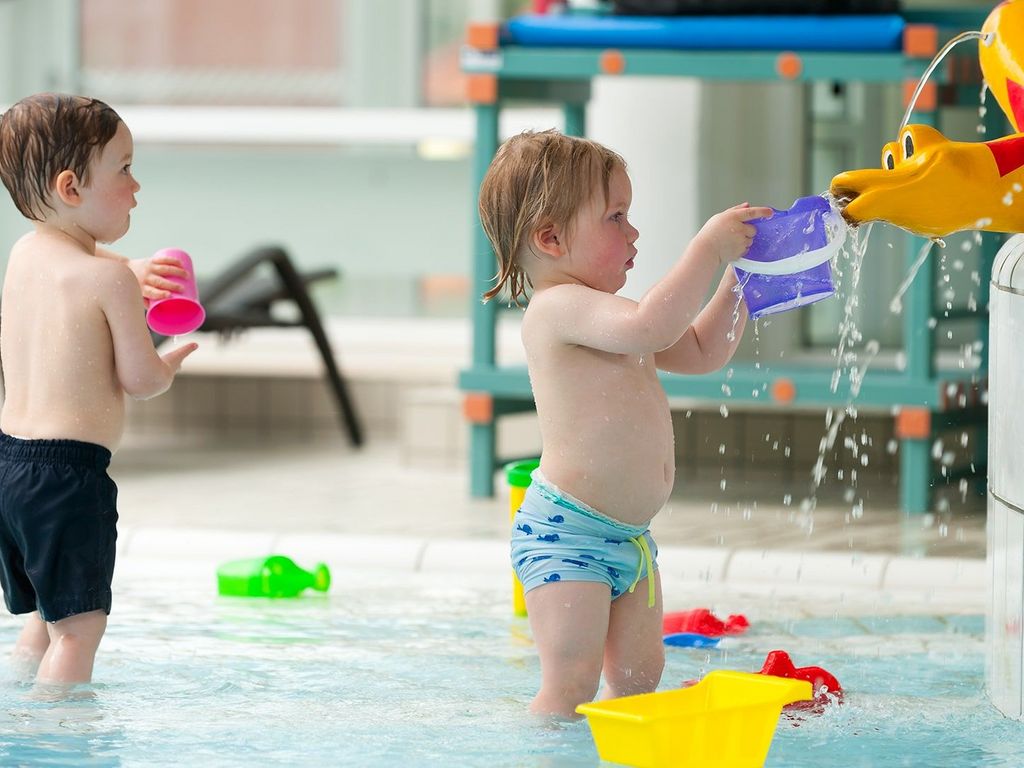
(502, 14), (904, 51)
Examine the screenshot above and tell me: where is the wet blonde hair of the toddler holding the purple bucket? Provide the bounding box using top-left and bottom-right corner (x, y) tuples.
(478, 130), (626, 304)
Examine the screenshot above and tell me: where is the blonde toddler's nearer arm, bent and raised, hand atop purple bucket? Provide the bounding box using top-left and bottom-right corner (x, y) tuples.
(524, 204), (772, 354)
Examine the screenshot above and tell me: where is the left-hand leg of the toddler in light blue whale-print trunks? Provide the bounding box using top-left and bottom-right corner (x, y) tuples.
(526, 582), (611, 718)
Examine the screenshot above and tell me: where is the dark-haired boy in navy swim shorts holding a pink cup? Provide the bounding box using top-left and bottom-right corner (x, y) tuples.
(0, 93), (197, 683)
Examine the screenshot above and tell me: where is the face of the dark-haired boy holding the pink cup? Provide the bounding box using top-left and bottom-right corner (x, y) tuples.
(77, 123), (140, 243)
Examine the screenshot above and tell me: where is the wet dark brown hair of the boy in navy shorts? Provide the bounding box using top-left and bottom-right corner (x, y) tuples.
(0, 93), (121, 221)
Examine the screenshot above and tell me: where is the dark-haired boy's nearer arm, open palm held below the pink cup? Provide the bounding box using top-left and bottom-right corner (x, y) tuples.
(100, 264), (199, 399)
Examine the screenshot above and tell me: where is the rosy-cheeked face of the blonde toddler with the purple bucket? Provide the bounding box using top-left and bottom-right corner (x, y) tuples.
(569, 168), (640, 293)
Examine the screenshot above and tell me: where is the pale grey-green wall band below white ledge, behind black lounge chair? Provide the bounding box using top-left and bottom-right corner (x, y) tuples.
(14, 145), (471, 276)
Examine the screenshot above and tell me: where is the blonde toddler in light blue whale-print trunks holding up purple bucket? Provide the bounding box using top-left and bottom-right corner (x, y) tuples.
(479, 131), (772, 718)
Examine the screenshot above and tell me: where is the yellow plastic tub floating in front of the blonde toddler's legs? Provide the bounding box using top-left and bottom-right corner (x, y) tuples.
(577, 670), (813, 768)
